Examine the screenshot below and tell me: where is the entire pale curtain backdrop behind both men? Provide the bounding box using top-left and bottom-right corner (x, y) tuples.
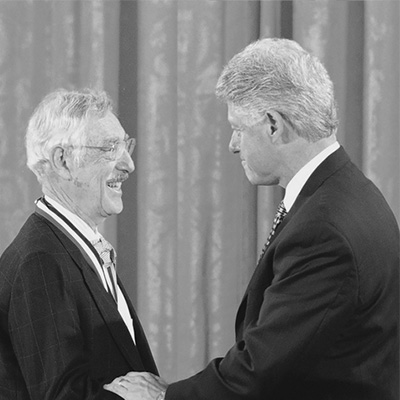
(0, 0), (400, 386)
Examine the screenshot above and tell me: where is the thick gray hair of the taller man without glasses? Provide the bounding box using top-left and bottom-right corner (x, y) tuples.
(216, 38), (338, 142)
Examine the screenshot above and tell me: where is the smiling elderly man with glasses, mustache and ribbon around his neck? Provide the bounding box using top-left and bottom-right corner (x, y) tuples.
(0, 90), (157, 400)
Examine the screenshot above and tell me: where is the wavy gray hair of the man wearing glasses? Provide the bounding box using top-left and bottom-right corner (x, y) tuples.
(25, 89), (112, 181)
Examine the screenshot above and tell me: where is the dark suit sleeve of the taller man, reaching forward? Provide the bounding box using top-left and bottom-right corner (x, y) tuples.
(166, 222), (358, 400)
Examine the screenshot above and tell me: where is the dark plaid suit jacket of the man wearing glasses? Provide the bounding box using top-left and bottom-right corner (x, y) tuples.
(0, 213), (157, 400)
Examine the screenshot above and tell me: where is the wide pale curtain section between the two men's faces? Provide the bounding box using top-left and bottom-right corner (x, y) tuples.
(137, 1), (258, 379)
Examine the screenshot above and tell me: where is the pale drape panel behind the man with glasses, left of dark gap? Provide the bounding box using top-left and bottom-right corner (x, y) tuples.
(0, 0), (119, 252)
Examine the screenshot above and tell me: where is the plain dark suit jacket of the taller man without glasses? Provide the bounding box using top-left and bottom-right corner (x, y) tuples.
(166, 148), (399, 400)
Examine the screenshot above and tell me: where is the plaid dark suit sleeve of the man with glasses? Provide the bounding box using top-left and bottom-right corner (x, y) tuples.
(9, 253), (119, 400)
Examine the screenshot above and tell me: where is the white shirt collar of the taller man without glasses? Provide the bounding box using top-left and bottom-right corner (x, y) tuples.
(283, 142), (340, 212)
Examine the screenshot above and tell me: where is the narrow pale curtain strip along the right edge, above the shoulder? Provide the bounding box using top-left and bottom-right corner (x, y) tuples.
(362, 1), (400, 212)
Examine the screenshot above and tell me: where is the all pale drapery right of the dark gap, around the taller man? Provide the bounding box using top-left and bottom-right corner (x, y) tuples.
(132, 0), (400, 379)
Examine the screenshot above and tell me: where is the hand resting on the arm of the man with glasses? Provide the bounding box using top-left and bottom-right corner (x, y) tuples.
(104, 372), (168, 400)
